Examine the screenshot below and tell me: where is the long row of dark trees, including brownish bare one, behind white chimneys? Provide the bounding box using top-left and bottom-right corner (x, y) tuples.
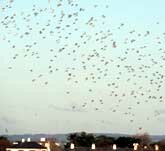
(65, 132), (165, 151)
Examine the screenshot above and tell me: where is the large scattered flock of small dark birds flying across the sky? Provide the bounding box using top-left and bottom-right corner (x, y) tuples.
(0, 0), (165, 130)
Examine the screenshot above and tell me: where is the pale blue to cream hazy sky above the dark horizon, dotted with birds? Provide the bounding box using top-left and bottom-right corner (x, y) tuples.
(0, 0), (165, 134)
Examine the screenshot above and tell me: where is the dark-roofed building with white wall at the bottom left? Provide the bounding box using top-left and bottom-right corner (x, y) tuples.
(6, 141), (48, 151)
